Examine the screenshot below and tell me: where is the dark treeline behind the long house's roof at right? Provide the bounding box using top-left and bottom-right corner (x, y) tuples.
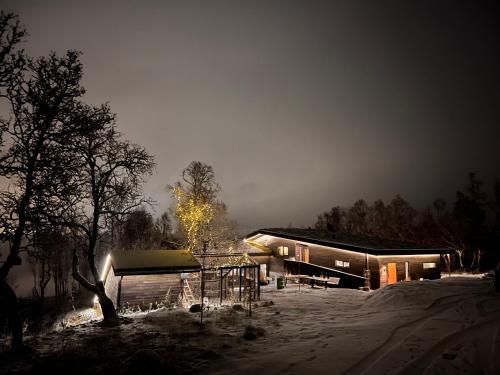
(314, 173), (500, 270)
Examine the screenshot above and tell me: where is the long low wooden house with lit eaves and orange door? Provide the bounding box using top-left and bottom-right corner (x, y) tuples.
(244, 228), (453, 289)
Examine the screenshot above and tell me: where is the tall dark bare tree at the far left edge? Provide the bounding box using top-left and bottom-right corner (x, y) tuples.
(0, 51), (84, 350)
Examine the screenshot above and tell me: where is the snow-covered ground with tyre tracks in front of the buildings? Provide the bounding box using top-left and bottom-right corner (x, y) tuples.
(0, 277), (500, 374)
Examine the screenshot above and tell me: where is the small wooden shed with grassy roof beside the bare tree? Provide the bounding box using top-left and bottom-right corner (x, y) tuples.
(102, 250), (201, 307)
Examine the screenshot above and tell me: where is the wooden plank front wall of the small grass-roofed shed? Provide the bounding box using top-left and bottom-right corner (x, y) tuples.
(120, 273), (182, 306)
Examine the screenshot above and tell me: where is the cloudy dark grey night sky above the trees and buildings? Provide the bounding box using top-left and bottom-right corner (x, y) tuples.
(2, 0), (500, 232)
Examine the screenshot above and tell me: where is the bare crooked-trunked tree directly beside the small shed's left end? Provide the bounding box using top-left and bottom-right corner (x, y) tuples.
(61, 106), (154, 323)
